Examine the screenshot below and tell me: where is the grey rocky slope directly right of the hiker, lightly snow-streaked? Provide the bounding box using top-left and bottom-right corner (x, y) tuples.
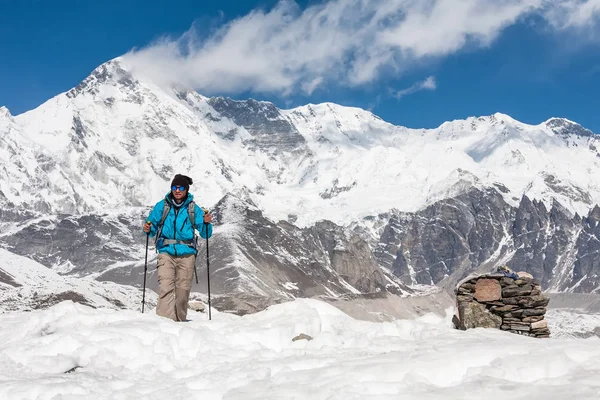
(190, 195), (405, 296)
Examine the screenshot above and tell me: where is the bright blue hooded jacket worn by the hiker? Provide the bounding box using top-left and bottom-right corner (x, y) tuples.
(146, 193), (212, 256)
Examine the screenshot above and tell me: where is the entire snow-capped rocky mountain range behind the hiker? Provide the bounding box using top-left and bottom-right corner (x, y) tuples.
(0, 59), (600, 312)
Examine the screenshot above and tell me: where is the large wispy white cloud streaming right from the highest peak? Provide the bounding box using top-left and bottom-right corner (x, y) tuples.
(125, 0), (600, 95)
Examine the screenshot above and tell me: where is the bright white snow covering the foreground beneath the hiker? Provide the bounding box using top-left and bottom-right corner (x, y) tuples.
(0, 299), (600, 400)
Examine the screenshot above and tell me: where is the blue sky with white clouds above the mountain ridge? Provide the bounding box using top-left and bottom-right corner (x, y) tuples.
(0, 0), (600, 133)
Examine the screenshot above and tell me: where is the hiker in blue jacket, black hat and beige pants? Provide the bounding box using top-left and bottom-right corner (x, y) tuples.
(143, 174), (212, 321)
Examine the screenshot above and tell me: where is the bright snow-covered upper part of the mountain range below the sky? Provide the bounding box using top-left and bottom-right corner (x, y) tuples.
(0, 58), (600, 226)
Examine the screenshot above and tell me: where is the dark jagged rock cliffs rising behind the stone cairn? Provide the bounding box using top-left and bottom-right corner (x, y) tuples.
(374, 189), (600, 295)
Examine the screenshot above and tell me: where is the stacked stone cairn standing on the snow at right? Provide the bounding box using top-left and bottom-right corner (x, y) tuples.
(453, 272), (550, 338)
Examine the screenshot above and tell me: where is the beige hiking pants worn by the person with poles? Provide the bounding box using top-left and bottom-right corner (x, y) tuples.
(156, 253), (196, 321)
